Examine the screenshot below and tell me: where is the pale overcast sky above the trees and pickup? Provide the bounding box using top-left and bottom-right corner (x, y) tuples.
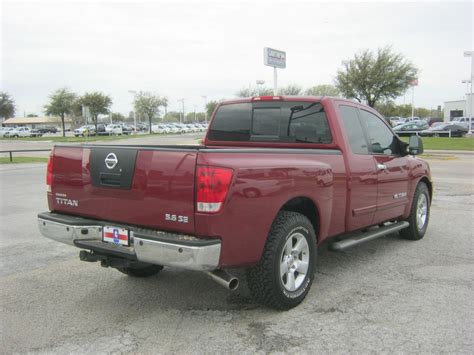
(0, 0), (474, 116)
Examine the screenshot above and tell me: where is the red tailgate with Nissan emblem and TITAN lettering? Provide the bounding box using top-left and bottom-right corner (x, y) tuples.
(48, 146), (198, 233)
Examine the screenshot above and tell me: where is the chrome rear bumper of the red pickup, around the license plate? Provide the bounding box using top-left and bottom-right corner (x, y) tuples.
(38, 212), (221, 271)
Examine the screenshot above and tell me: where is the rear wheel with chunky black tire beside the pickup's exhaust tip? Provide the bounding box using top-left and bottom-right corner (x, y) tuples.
(246, 211), (316, 310)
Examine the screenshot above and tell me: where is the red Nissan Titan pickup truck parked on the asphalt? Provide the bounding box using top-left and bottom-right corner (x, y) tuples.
(38, 96), (433, 309)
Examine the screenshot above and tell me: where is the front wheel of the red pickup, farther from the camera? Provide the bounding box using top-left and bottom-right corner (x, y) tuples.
(400, 182), (431, 240)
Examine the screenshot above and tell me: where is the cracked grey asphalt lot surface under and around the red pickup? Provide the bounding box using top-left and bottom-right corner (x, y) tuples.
(0, 147), (474, 353)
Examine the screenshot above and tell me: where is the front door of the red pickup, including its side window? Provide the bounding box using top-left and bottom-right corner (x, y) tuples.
(359, 109), (409, 224)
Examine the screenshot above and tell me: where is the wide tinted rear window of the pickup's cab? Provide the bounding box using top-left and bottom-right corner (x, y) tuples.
(208, 101), (332, 144)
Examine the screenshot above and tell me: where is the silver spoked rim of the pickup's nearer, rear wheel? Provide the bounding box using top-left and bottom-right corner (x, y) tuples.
(280, 233), (309, 291)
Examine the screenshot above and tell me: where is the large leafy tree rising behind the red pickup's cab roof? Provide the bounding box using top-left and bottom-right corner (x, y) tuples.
(335, 47), (418, 107)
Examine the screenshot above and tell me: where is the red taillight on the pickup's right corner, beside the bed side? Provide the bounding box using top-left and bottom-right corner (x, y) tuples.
(196, 166), (232, 213)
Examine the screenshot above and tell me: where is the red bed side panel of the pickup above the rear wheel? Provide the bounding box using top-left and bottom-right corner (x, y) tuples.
(195, 149), (346, 267)
